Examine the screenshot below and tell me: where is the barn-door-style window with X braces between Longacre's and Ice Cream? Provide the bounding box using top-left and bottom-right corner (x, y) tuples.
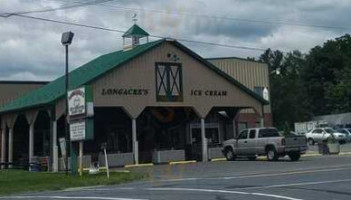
(155, 63), (183, 102)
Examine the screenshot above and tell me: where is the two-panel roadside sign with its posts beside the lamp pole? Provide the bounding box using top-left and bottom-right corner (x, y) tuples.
(67, 86), (94, 176)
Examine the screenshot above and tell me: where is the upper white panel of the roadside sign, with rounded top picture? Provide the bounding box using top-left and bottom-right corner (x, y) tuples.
(68, 87), (85, 116)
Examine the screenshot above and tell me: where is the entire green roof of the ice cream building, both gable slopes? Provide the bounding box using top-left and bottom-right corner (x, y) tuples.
(0, 39), (268, 113)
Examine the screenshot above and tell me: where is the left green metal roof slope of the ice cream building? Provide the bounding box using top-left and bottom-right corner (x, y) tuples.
(0, 40), (164, 113)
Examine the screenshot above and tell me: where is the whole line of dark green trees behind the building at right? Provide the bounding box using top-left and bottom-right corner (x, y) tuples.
(259, 34), (351, 129)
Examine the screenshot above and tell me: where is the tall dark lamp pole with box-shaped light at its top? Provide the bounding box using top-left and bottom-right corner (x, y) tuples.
(61, 31), (74, 174)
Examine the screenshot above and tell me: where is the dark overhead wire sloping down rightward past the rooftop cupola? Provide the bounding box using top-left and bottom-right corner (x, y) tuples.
(0, 14), (267, 51)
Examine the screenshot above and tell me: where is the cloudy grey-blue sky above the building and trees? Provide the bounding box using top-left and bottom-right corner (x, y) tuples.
(0, 0), (351, 81)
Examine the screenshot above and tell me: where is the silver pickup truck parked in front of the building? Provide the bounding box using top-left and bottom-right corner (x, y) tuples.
(222, 127), (307, 161)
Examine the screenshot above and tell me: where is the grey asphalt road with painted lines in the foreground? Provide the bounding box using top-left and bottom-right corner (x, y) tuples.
(2, 155), (351, 200)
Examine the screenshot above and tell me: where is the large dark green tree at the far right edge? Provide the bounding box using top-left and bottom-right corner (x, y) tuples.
(302, 34), (351, 115)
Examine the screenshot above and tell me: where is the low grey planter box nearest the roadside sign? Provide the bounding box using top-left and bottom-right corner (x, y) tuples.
(99, 152), (134, 167)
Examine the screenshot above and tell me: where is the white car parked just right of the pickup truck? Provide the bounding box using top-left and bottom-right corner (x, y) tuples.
(306, 128), (347, 145)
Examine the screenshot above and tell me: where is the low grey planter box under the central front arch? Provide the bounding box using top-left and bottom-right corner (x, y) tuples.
(152, 149), (185, 163)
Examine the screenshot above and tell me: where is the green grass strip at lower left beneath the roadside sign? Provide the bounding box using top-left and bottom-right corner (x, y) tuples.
(0, 170), (144, 196)
